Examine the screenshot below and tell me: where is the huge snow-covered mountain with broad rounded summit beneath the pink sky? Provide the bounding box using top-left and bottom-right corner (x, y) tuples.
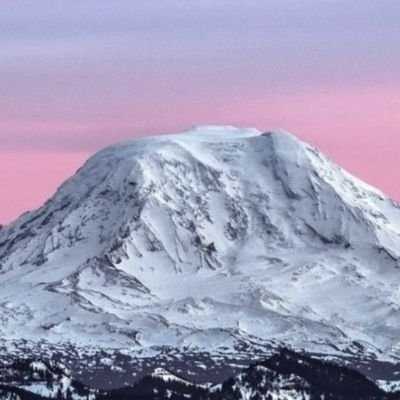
(0, 127), (400, 387)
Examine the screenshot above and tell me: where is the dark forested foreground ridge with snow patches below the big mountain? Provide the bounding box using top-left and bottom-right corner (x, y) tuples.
(0, 349), (400, 400)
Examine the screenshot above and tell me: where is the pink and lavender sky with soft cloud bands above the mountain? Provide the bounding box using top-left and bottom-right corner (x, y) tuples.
(0, 0), (400, 223)
